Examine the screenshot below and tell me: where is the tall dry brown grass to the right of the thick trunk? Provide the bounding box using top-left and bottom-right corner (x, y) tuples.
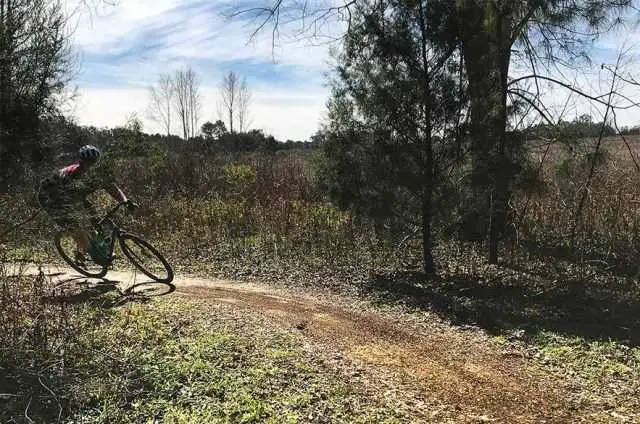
(514, 137), (640, 273)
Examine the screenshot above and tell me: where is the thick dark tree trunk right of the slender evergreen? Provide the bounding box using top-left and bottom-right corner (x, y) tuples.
(458, 0), (511, 264)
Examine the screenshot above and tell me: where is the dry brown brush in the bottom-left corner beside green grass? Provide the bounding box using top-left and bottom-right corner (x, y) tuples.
(0, 254), (87, 422)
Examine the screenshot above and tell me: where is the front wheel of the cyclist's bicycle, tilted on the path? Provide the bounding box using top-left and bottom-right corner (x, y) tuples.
(120, 233), (173, 283)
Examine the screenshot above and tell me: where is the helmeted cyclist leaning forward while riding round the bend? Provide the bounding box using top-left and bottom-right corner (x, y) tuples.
(38, 145), (134, 264)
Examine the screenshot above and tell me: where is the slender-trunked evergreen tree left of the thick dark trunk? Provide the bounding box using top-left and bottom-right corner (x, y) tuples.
(320, 0), (461, 274)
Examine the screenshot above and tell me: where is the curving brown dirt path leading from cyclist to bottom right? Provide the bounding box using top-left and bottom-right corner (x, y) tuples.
(12, 266), (584, 423)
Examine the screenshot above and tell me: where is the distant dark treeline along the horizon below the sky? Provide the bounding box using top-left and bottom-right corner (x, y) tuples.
(50, 111), (640, 166)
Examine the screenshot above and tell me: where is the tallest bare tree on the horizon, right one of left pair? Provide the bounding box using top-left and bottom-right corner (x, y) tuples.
(173, 67), (202, 140)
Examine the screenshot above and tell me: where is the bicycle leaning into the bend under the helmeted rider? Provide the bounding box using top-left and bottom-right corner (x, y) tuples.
(55, 202), (174, 283)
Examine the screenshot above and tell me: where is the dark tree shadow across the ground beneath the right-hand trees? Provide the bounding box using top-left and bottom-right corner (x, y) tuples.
(363, 269), (640, 346)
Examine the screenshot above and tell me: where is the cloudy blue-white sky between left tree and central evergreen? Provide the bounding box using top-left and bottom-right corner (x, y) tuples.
(69, 0), (336, 140)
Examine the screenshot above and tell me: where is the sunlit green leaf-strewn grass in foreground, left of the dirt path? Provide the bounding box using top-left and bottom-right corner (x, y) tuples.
(0, 274), (407, 423)
